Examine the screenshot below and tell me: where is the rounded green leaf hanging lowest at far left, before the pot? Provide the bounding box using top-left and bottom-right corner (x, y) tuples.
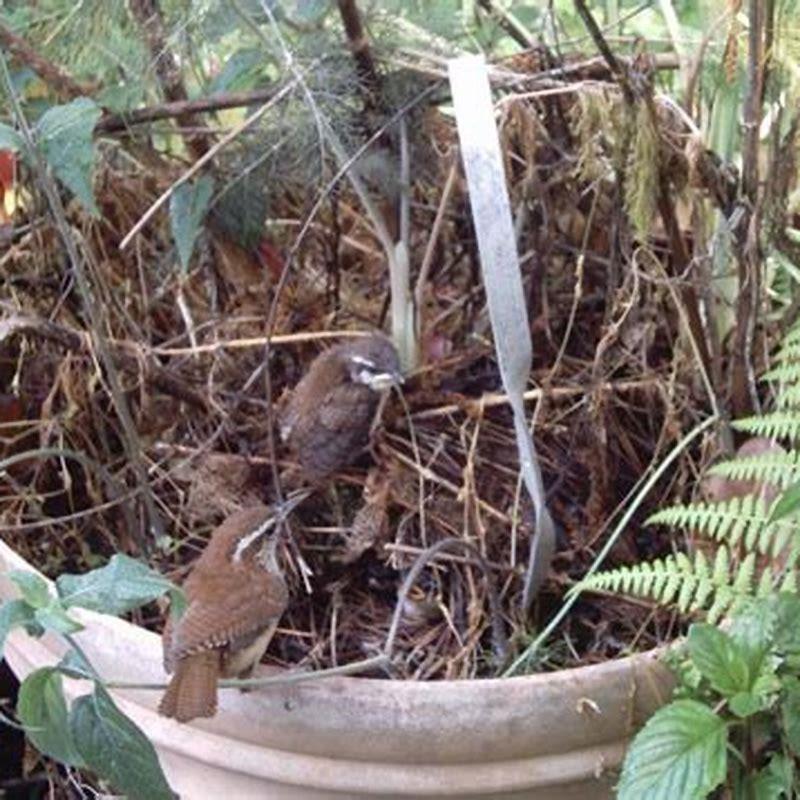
(17, 667), (81, 767)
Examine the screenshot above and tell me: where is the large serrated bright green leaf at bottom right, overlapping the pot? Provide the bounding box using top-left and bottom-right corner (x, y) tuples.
(618, 700), (727, 800)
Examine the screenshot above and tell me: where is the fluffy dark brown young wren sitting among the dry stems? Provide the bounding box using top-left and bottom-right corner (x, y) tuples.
(279, 334), (403, 483)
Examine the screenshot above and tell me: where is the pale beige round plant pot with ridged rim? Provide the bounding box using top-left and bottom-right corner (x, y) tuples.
(0, 542), (671, 800)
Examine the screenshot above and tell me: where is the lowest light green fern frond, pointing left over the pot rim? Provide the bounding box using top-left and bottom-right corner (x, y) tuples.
(576, 547), (755, 622)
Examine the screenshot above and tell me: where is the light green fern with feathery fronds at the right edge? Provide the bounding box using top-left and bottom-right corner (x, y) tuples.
(576, 326), (800, 623)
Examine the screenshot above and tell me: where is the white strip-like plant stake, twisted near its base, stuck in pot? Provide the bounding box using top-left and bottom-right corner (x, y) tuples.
(448, 55), (555, 609)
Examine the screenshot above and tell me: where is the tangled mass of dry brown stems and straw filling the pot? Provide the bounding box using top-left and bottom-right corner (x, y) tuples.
(0, 56), (720, 679)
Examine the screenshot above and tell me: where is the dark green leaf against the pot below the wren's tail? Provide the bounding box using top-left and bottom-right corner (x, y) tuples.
(69, 684), (175, 800)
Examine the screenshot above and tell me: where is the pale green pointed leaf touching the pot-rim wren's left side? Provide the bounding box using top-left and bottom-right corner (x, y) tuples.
(56, 553), (177, 616)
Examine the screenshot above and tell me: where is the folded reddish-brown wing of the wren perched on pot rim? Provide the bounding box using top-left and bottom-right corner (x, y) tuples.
(165, 568), (288, 663)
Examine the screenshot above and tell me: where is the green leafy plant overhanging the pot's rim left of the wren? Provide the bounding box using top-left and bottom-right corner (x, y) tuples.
(0, 554), (178, 800)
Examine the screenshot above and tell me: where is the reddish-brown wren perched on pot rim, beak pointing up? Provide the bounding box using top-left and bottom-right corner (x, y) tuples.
(158, 491), (308, 722)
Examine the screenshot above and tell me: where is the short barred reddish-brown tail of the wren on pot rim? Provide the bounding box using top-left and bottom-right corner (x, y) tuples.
(158, 650), (220, 722)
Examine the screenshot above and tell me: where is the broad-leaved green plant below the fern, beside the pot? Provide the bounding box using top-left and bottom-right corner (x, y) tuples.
(619, 593), (800, 800)
